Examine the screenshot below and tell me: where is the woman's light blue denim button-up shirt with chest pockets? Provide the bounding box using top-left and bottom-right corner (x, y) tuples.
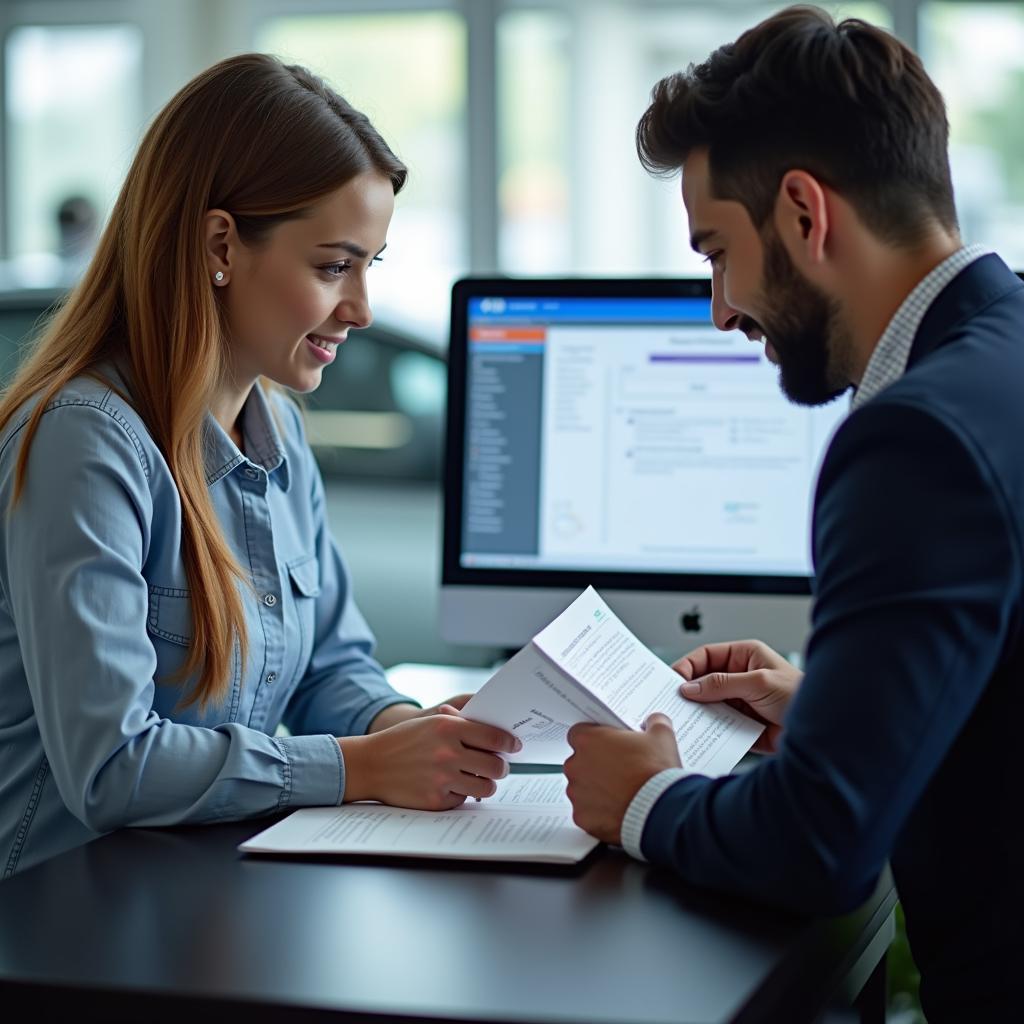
(0, 364), (415, 878)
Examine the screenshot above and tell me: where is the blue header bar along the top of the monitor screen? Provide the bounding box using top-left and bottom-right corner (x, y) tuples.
(469, 295), (711, 324)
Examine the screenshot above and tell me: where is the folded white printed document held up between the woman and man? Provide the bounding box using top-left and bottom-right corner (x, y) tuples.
(462, 587), (764, 775)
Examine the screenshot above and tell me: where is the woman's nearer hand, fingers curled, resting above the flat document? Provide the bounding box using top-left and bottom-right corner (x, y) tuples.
(338, 695), (522, 811)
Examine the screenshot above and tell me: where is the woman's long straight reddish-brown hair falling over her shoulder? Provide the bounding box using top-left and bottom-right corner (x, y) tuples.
(0, 53), (407, 708)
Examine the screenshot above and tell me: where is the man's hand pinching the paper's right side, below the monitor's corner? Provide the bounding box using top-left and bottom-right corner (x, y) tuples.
(673, 640), (804, 754)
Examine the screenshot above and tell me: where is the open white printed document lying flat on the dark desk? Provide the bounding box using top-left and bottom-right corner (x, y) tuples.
(239, 775), (597, 864)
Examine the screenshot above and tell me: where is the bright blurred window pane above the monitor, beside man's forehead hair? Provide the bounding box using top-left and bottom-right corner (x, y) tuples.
(497, 2), (892, 274)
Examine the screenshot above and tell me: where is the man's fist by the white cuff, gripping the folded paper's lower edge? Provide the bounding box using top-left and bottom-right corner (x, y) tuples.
(565, 713), (680, 845)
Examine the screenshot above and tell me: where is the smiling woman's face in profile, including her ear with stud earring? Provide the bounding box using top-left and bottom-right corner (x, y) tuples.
(208, 172), (394, 392)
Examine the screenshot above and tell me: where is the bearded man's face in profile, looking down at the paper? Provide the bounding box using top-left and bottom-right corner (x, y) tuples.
(683, 150), (851, 406)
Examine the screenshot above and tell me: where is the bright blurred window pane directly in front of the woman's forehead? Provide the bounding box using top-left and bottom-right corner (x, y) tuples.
(256, 11), (468, 344)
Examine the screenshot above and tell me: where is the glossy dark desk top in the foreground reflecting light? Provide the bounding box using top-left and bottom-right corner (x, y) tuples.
(0, 822), (895, 1024)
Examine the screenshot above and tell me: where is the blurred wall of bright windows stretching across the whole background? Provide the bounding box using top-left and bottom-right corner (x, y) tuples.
(0, 0), (1024, 321)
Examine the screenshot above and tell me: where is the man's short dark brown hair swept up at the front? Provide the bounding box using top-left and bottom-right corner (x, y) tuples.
(637, 6), (956, 246)
